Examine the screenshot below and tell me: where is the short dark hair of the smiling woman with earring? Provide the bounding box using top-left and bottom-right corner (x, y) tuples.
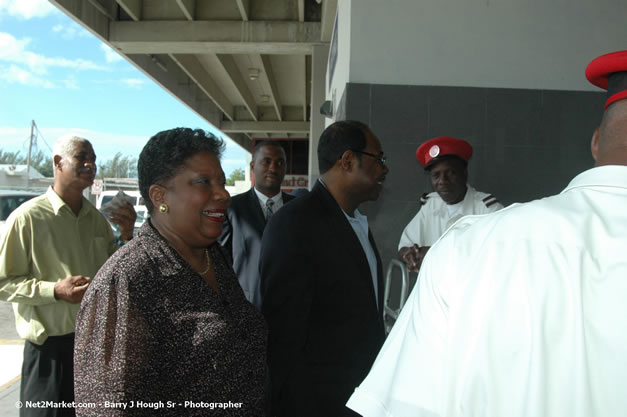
(137, 127), (225, 213)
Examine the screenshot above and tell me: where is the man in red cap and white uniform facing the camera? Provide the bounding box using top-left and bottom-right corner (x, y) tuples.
(398, 136), (503, 272)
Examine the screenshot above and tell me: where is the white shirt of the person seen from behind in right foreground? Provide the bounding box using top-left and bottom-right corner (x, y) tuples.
(348, 166), (627, 417)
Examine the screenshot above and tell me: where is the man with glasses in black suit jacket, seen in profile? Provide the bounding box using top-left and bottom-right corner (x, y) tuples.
(259, 121), (388, 417)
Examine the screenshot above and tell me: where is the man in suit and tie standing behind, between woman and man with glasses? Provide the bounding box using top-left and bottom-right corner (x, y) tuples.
(218, 141), (294, 308)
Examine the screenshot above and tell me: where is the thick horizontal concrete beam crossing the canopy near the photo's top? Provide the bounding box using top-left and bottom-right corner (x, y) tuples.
(109, 21), (325, 55)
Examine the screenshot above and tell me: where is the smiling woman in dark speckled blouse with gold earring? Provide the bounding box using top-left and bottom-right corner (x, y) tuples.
(75, 128), (267, 416)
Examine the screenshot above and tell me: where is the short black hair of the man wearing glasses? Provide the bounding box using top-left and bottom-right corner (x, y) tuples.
(318, 120), (370, 174)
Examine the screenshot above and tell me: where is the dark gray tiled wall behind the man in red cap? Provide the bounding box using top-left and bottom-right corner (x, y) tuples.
(338, 83), (605, 280)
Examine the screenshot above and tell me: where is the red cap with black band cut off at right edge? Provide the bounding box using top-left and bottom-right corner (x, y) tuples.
(586, 51), (627, 109)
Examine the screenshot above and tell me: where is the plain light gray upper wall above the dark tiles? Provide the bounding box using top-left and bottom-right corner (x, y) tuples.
(350, 0), (627, 92)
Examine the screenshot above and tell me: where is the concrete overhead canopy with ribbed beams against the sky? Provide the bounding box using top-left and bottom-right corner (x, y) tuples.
(50, 0), (337, 150)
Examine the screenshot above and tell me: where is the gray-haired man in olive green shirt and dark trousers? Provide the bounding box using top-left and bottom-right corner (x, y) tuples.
(0, 136), (135, 416)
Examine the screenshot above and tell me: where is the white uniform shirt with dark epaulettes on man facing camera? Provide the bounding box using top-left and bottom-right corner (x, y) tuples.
(398, 184), (503, 250)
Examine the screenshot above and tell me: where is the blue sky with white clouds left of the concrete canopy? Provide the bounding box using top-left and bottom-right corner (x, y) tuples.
(0, 0), (249, 177)
